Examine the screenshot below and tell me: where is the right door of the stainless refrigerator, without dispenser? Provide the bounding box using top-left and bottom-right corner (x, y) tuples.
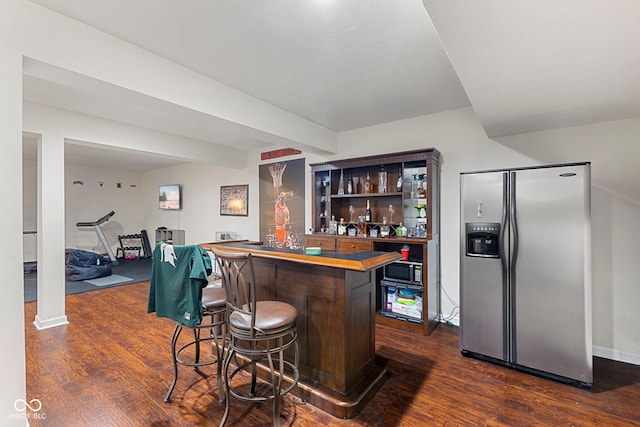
(511, 165), (592, 383)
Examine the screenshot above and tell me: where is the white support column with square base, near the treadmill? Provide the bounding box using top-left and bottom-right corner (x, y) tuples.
(33, 132), (69, 329)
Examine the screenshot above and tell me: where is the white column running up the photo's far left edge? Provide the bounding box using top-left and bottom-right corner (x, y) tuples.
(0, 32), (28, 427)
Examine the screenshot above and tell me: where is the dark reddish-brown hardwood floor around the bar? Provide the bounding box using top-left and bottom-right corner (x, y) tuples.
(25, 282), (640, 427)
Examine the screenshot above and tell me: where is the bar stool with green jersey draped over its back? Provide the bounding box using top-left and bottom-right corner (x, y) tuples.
(148, 243), (227, 402)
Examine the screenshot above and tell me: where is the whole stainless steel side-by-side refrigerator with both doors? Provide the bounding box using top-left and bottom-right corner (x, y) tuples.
(460, 163), (593, 387)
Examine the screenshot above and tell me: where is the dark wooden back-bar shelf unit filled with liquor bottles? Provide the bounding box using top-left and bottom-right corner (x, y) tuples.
(305, 148), (440, 335)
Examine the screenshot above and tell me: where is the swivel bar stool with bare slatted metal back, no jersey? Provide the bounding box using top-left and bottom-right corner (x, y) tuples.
(212, 247), (306, 427)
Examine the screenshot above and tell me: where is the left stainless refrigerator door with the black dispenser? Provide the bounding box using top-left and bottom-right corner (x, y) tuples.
(460, 172), (508, 360)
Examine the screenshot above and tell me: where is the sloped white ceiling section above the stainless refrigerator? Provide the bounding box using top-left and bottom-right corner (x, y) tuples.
(424, 0), (640, 137)
